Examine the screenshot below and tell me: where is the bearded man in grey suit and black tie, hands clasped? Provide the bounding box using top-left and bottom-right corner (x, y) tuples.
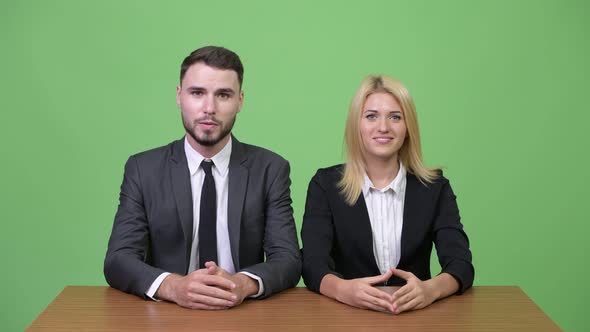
(104, 46), (301, 309)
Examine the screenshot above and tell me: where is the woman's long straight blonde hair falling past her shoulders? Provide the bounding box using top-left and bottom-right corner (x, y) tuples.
(338, 75), (438, 205)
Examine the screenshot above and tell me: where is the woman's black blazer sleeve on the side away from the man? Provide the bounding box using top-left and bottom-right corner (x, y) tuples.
(433, 178), (475, 293)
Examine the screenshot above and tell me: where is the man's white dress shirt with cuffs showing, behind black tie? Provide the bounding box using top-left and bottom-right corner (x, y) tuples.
(146, 137), (264, 299)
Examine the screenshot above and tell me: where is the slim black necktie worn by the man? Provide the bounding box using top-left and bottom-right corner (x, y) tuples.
(199, 160), (219, 269)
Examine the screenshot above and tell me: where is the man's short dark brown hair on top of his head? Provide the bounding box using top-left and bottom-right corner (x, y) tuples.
(180, 46), (244, 88)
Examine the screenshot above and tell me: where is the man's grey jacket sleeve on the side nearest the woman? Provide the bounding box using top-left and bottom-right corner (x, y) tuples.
(243, 160), (301, 299)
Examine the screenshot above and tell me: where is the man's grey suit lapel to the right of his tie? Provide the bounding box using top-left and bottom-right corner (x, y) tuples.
(227, 136), (249, 271)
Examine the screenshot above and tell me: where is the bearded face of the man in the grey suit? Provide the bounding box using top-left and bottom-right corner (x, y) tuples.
(176, 63), (244, 147)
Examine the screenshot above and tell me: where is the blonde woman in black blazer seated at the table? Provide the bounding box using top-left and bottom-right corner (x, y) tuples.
(301, 76), (474, 313)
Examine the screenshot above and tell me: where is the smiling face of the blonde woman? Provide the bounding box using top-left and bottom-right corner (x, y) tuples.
(360, 92), (406, 161)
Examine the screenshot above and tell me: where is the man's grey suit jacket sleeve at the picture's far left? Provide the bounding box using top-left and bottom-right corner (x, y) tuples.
(104, 157), (166, 297)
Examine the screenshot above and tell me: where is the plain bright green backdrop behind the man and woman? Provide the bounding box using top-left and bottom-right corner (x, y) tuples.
(0, 0), (590, 330)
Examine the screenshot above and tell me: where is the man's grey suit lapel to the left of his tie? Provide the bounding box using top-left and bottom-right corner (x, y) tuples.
(170, 139), (193, 271)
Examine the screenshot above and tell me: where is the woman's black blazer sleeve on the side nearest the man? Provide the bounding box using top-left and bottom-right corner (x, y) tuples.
(301, 171), (342, 293)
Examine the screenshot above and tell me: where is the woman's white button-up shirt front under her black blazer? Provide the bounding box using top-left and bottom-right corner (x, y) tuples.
(363, 162), (406, 273)
